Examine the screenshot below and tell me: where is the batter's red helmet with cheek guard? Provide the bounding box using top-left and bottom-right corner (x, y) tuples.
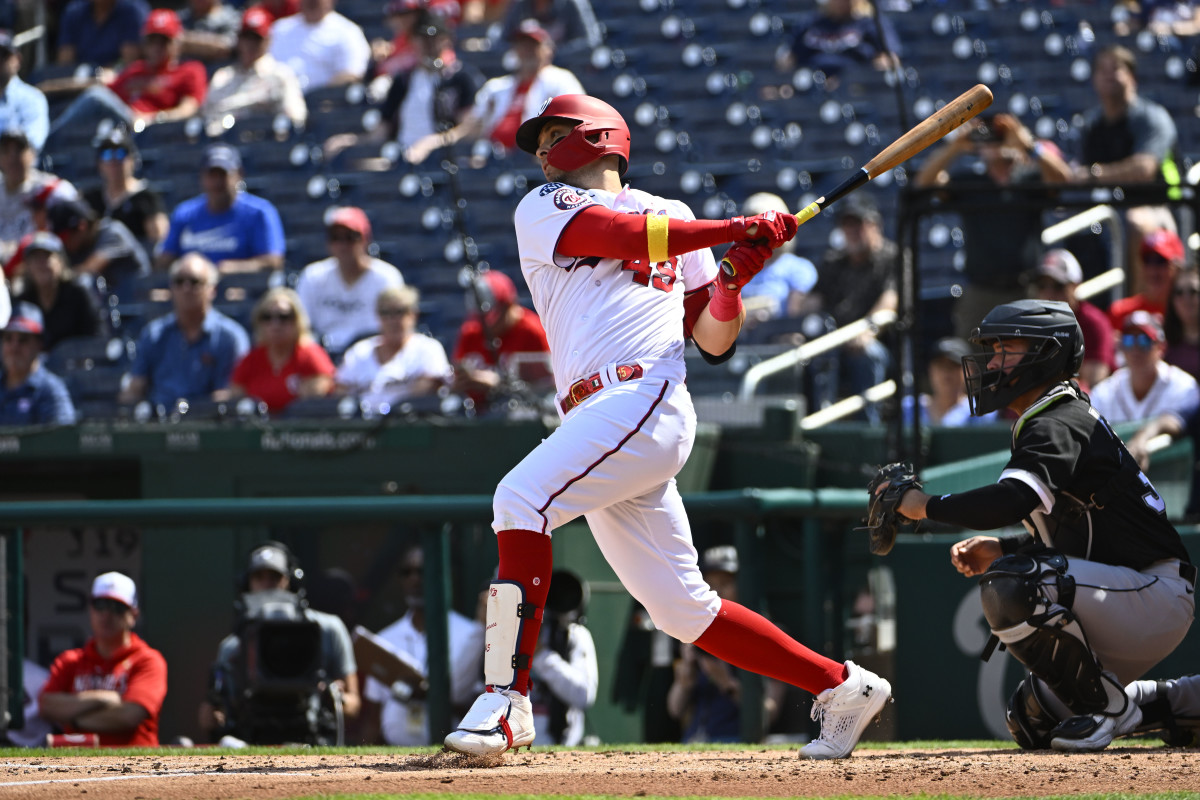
(517, 95), (629, 175)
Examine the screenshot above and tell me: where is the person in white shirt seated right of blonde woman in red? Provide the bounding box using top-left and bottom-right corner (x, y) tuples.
(337, 287), (452, 413)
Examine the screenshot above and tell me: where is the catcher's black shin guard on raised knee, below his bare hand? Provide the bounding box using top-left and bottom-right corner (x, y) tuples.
(979, 554), (1108, 714)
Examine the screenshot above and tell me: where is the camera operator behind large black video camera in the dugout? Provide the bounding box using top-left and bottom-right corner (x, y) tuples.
(200, 541), (361, 744)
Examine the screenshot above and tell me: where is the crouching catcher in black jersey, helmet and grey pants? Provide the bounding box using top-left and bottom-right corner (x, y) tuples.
(869, 300), (1196, 751)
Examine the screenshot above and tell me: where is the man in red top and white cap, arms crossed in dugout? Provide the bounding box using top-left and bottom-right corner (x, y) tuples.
(38, 572), (167, 747)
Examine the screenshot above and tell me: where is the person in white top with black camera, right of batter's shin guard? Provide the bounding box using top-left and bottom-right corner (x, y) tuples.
(529, 570), (600, 745)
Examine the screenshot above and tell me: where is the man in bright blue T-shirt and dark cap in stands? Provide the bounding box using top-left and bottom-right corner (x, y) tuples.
(157, 144), (286, 275)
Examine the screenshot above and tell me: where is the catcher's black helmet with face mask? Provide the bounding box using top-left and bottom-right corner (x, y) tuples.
(962, 300), (1084, 416)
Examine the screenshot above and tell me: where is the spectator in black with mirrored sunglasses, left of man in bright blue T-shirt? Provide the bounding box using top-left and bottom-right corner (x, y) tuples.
(84, 126), (168, 252)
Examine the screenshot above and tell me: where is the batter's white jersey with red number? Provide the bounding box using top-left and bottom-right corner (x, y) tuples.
(515, 184), (716, 397)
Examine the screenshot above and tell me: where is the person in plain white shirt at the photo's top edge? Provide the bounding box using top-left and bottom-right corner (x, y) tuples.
(270, 0), (371, 92)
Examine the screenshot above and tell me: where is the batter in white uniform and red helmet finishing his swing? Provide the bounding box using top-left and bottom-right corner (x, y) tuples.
(445, 95), (892, 758)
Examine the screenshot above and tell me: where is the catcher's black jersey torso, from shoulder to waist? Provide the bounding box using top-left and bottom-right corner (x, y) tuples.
(1006, 384), (1190, 570)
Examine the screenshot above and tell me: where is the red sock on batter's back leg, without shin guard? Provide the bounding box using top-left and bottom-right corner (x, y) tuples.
(696, 600), (847, 694)
